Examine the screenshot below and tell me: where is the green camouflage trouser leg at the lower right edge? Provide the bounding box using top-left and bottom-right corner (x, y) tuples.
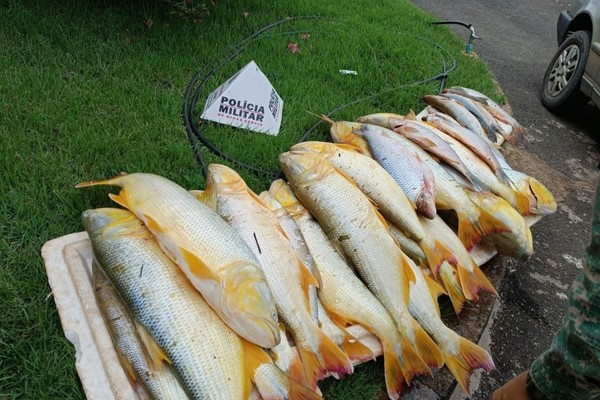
(529, 183), (600, 400)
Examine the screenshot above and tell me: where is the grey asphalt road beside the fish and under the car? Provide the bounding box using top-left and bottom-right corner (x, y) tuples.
(413, 0), (600, 400)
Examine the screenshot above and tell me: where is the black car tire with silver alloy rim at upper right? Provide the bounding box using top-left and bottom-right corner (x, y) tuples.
(541, 31), (592, 114)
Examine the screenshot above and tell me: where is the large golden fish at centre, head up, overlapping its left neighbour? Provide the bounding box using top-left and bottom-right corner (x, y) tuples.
(279, 152), (442, 378)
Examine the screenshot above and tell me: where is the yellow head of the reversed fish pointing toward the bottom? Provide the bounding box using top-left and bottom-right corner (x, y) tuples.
(221, 263), (281, 349)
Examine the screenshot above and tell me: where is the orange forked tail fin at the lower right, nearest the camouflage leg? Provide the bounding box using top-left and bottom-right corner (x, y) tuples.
(445, 337), (495, 396)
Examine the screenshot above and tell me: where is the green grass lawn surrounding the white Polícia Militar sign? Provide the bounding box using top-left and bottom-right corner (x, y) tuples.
(0, 0), (498, 399)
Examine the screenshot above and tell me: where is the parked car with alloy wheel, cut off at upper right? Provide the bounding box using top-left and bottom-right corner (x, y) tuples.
(541, 0), (600, 114)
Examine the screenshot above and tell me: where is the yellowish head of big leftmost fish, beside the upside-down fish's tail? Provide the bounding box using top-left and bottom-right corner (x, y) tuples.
(81, 208), (150, 238)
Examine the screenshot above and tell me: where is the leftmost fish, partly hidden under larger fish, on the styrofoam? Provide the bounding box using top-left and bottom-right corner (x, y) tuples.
(92, 260), (188, 400)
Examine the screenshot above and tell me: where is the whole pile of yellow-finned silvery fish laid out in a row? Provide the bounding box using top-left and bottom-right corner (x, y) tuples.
(77, 87), (556, 400)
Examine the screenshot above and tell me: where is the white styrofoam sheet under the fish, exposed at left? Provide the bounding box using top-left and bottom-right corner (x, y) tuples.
(42, 217), (539, 400)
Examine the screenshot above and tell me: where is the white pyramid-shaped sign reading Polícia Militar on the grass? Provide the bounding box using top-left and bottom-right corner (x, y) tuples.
(201, 61), (283, 136)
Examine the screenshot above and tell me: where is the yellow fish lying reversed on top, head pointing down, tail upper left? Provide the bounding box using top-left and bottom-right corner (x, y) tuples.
(77, 173), (279, 348)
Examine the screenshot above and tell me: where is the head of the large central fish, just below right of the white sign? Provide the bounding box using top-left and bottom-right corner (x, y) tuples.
(279, 151), (334, 185)
